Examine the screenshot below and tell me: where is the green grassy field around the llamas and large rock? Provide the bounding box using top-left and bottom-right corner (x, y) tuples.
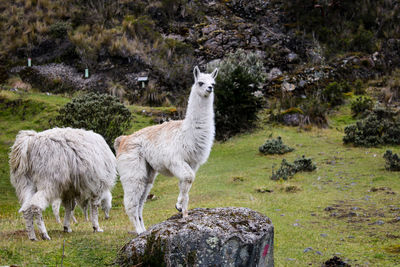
(0, 92), (400, 266)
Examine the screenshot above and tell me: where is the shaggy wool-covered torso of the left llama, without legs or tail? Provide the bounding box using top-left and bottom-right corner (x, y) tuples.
(10, 128), (116, 201)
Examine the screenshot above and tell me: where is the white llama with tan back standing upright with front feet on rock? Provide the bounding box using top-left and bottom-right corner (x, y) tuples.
(114, 67), (218, 234)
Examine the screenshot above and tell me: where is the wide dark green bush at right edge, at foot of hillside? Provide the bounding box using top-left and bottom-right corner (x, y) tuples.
(343, 108), (400, 147)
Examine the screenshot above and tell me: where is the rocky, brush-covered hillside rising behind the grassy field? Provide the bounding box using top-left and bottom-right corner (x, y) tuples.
(0, 0), (400, 102)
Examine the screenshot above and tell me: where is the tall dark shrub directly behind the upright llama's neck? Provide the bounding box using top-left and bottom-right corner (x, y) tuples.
(215, 50), (264, 140)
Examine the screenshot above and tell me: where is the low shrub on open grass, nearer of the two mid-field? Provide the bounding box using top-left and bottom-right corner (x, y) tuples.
(271, 155), (317, 180)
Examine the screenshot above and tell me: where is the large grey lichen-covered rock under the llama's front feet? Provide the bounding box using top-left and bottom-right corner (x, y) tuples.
(117, 208), (274, 266)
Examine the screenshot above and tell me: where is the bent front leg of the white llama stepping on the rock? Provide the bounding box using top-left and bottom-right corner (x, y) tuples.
(170, 163), (195, 218)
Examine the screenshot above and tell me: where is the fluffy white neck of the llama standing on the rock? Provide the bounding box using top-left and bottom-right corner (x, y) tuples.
(183, 88), (215, 139)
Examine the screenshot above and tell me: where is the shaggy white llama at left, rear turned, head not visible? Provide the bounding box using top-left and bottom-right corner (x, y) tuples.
(10, 128), (116, 240)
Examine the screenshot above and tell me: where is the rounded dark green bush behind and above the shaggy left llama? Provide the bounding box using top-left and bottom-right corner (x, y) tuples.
(55, 93), (132, 149)
